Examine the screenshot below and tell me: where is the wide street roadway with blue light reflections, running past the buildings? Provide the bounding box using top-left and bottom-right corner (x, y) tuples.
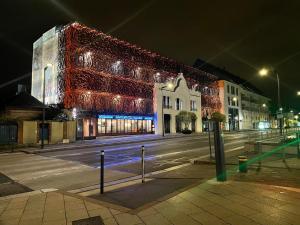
(0, 133), (268, 193)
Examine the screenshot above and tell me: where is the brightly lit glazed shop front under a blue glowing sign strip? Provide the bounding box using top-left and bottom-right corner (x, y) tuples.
(97, 115), (154, 136)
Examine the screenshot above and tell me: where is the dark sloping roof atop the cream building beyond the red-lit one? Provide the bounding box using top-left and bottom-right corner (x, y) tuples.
(194, 58), (266, 97)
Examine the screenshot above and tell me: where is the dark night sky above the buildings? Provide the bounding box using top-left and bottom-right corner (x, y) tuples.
(0, 0), (300, 109)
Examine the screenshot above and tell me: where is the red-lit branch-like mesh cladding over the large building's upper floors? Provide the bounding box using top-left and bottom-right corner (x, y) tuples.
(59, 23), (221, 115)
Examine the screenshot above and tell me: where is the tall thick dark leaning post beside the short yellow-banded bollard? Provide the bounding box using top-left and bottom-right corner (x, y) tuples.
(214, 121), (227, 181)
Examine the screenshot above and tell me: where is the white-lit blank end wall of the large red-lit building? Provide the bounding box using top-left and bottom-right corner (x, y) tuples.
(31, 27), (60, 104)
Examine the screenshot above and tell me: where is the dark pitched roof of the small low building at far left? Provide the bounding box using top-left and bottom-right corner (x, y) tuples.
(5, 92), (47, 109)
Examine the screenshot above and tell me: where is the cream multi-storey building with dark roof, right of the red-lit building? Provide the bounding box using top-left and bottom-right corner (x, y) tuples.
(194, 59), (271, 130)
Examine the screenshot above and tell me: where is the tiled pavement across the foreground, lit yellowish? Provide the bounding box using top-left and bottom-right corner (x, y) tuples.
(0, 181), (300, 225)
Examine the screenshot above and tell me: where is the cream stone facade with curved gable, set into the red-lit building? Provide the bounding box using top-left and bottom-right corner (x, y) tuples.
(153, 74), (202, 134)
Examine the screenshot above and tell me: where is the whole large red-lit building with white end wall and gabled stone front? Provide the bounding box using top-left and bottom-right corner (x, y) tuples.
(31, 23), (221, 138)
